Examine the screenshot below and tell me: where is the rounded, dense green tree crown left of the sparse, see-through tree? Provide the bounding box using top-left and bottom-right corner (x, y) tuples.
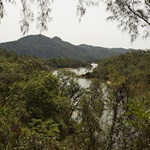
(23, 74), (58, 119)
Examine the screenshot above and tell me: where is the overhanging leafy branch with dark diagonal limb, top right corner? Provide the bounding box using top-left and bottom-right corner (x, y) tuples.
(106, 0), (150, 41)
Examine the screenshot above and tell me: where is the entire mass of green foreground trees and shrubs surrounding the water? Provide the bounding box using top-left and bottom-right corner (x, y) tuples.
(0, 50), (150, 150)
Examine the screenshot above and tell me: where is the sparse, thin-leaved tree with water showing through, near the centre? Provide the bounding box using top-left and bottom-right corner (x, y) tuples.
(57, 70), (84, 118)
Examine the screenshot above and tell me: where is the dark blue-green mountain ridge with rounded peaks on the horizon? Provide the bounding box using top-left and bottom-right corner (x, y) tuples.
(0, 34), (131, 61)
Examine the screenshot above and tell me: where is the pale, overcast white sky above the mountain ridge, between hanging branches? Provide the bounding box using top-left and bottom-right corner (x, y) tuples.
(0, 0), (150, 49)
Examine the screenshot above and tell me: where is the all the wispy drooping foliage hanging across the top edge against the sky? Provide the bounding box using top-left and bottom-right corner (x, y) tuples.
(0, 0), (150, 41)
